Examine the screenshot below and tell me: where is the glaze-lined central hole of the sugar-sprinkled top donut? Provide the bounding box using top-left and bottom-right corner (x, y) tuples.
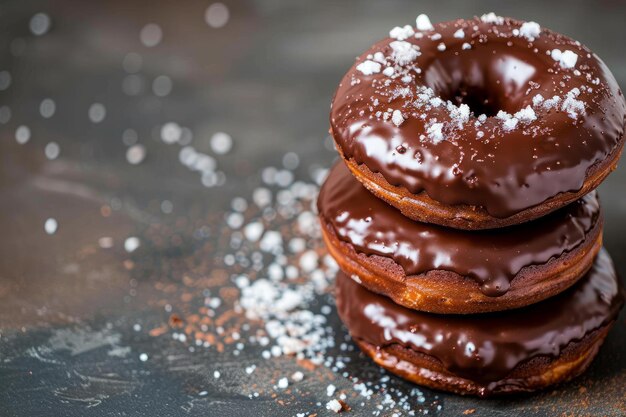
(424, 44), (549, 117)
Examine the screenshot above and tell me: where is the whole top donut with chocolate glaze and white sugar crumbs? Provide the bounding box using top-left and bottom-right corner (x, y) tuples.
(330, 13), (626, 229)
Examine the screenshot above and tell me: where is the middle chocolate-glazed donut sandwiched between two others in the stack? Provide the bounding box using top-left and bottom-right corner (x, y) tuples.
(318, 163), (602, 314)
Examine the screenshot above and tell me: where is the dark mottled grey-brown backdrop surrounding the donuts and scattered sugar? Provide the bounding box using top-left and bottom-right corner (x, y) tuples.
(0, 0), (626, 416)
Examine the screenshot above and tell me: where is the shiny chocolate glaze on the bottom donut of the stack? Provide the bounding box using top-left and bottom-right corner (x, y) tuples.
(336, 250), (624, 386)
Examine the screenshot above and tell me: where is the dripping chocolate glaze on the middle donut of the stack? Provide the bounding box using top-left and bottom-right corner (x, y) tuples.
(318, 162), (600, 296)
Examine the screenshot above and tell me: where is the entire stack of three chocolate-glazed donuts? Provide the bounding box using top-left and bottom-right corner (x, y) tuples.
(318, 13), (626, 396)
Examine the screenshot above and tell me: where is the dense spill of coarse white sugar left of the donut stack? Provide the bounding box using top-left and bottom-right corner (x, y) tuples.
(137, 154), (441, 415)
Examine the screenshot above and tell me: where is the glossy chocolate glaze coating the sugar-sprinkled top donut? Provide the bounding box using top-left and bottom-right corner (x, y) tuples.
(330, 19), (626, 218)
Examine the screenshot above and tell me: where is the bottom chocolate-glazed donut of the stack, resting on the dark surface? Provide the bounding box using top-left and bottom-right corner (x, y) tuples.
(336, 251), (624, 396)
